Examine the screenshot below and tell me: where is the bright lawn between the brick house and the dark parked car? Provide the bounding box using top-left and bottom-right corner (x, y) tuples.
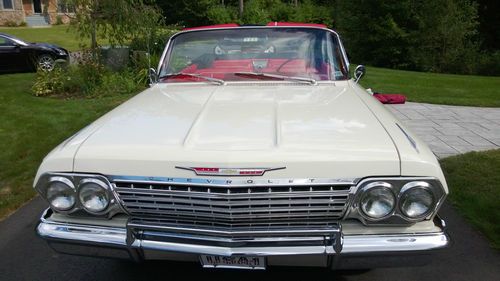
(0, 25), (102, 51)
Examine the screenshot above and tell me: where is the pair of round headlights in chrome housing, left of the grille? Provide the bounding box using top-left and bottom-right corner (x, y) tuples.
(36, 174), (118, 215)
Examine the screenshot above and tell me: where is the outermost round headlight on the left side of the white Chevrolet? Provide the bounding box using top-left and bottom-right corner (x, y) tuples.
(45, 177), (75, 211)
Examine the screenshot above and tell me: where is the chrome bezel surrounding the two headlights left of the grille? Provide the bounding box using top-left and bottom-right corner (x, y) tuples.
(35, 173), (125, 218)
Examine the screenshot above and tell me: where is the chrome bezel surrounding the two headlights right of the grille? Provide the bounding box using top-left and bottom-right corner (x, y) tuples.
(345, 177), (446, 226)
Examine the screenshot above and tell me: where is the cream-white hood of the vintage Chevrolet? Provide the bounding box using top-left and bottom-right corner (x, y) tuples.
(69, 82), (400, 178)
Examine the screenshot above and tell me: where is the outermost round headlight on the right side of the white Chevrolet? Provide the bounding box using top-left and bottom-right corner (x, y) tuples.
(400, 183), (434, 219)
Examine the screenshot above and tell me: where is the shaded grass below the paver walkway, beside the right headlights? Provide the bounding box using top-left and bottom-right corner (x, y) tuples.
(441, 149), (500, 250)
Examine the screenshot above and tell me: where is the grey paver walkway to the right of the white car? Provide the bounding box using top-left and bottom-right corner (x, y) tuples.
(387, 102), (500, 158)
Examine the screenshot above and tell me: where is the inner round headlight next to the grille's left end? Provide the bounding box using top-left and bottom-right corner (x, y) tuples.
(78, 179), (109, 213)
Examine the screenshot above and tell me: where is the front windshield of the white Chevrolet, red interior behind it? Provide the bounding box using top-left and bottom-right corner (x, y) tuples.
(159, 28), (348, 83)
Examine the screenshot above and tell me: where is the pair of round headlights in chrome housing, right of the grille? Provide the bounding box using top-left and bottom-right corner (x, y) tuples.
(349, 179), (446, 223)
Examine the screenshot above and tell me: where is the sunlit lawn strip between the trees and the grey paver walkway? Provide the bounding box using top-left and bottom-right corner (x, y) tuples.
(361, 67), (500, 107)
